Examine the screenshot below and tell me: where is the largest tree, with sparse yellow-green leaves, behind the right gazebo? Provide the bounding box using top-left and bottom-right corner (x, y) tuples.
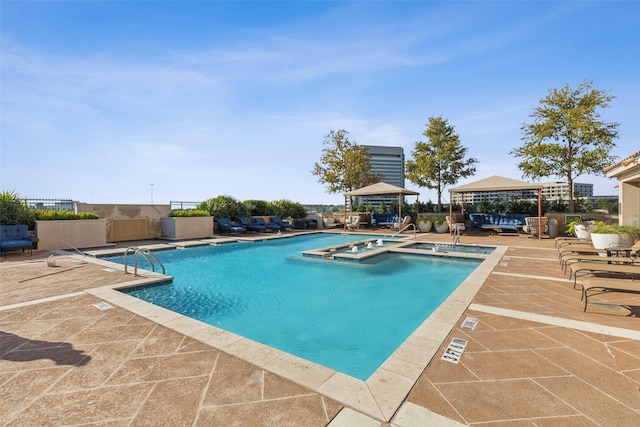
(511, 80), (618, 213)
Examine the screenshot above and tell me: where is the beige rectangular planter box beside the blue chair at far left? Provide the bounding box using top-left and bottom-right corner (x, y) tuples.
(36, 219), (107, 251)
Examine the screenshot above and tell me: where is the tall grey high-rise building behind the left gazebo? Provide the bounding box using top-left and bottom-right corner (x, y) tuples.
(355, 145), (405, 208)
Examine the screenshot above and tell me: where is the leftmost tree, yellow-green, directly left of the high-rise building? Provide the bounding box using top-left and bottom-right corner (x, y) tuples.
(311, 129), (380, 206)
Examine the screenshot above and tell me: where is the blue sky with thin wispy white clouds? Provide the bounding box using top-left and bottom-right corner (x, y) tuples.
(0, 0), (640, 204)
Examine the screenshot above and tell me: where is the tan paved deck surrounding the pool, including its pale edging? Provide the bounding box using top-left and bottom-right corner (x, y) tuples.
(0, 231), (640, 427)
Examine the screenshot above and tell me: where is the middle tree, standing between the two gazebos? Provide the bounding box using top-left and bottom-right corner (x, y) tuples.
(405, 116), (478, 212)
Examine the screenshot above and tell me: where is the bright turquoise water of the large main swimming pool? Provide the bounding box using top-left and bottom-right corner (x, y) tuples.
(110, 234), (479, 380)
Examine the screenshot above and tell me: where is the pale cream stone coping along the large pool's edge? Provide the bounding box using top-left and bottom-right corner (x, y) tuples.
(85, 239), (508, 422)
